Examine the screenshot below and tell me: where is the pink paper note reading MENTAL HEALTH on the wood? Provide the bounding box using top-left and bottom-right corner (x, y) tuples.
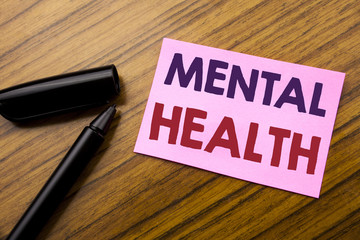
(134, 39), (345, 197)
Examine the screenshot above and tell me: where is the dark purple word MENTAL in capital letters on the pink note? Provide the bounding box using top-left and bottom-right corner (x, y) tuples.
(164, 53), (326, 117)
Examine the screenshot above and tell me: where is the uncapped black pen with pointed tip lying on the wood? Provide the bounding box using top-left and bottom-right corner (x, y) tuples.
(7, 105), (116, 240)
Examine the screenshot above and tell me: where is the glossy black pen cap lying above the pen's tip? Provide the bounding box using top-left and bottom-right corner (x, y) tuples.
(0, 65), (120, 121)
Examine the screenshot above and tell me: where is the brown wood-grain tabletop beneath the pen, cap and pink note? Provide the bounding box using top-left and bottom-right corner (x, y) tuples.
(0, 0), (360, 239)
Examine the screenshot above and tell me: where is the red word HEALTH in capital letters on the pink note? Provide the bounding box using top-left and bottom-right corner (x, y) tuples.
(149, 102), (321, 174)
